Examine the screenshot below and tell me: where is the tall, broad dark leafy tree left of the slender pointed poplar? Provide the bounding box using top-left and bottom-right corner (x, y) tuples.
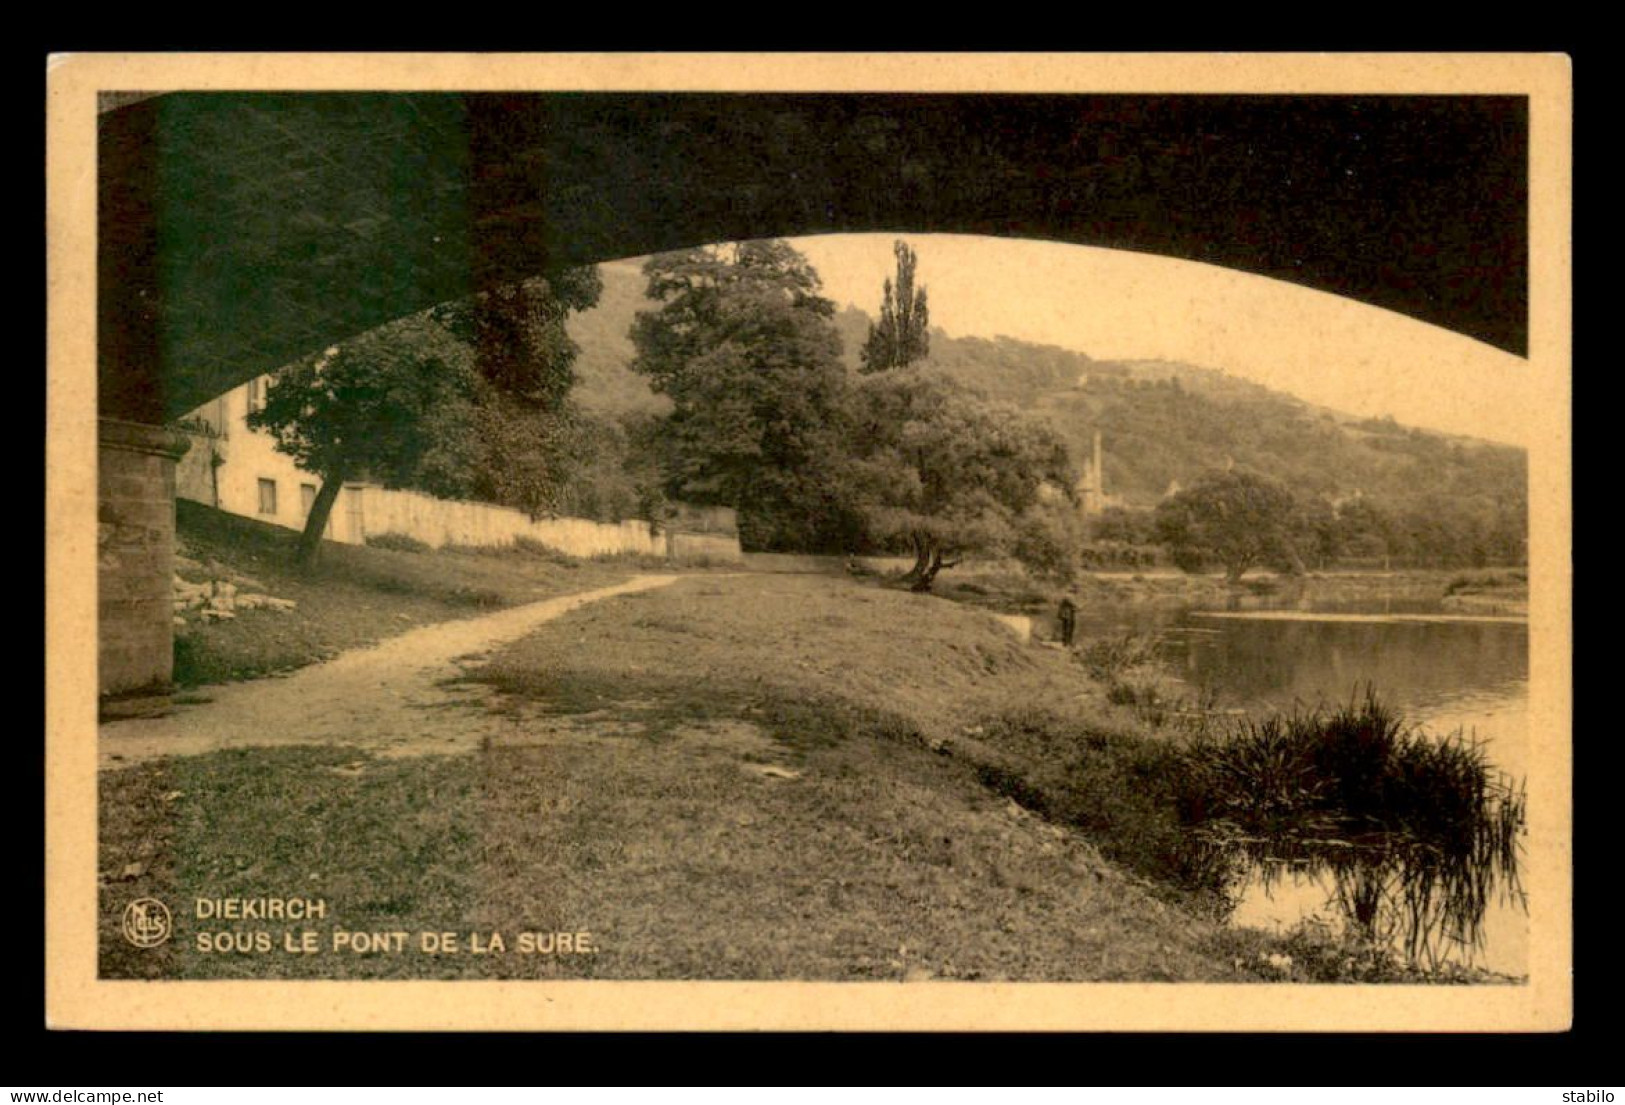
(632, 241), (856, 549)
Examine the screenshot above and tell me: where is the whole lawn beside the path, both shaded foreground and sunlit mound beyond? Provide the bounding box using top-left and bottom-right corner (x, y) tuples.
(99, 575), (1259, 982)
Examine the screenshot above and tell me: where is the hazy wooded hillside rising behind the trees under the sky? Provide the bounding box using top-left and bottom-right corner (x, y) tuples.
(570, 263), (1528, 516)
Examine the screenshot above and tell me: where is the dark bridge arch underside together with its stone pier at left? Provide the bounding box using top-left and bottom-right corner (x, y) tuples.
(98, 93), (1528, 691)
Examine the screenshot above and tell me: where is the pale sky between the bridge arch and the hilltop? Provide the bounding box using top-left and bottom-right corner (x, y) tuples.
(773, 234), (1534, 445)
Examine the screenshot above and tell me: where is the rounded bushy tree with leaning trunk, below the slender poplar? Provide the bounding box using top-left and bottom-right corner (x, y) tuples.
(853, 367), (1076, 592)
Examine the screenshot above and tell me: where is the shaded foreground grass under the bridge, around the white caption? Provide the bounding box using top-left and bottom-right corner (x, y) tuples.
(101, 707), (1253, 982)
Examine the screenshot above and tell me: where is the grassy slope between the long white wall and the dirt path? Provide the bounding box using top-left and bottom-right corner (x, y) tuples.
(174, 501), (626, 687)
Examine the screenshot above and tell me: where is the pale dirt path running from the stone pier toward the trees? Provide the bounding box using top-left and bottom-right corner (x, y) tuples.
(98, 575), (678, 769)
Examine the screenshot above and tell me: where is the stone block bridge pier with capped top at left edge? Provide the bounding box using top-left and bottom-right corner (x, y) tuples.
(96, 418), (187, 694)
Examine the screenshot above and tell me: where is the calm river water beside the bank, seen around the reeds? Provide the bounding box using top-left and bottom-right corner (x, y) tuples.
(1079, 583), (1529, 975)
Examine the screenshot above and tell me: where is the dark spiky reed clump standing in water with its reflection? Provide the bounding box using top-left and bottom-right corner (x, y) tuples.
(1178, 689), (1526, 962)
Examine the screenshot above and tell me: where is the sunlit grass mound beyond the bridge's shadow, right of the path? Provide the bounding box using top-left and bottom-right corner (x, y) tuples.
(468, 575), (1099, 741)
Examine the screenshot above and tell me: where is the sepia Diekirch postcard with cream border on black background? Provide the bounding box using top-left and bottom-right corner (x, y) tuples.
(46, 55), (1573, 1030)
